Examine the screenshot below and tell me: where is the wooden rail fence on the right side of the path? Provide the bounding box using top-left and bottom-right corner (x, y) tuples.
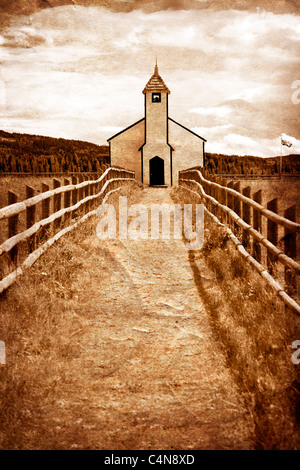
(179, 169), (300, 314)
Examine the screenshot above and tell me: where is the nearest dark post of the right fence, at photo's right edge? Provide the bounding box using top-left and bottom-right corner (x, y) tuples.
(284, 205), (298, 297)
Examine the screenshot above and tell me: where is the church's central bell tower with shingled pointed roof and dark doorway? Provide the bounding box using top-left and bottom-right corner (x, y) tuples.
(141, 62), (172, 185)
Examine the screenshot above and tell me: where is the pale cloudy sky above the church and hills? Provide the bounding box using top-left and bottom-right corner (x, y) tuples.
(0, 0), (300, 156)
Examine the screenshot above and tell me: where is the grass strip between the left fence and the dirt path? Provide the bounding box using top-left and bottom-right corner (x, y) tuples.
(0, 221), (97, 449)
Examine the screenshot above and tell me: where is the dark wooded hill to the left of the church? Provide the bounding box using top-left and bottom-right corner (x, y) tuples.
(0, 130), (109, 173)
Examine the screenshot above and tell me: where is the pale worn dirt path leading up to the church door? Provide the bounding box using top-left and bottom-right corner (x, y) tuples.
(63, 188), (252, 449)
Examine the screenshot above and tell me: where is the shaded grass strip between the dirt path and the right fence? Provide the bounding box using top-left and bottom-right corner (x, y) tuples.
(173, 188), (300, 449)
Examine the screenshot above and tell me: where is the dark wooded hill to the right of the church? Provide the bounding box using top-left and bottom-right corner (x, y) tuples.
(205, 153), (300, 175)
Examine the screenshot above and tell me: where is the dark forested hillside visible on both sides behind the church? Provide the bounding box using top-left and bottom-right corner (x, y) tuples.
(0, 130), (300, 175)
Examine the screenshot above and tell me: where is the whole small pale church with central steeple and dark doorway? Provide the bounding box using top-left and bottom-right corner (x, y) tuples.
(108, 64), (206, 186)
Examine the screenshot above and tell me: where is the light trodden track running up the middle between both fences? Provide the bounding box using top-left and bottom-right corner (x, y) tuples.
(88, 188), (251, 449)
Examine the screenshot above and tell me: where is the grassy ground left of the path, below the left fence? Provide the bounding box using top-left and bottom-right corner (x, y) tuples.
(0, 180), (138, 450)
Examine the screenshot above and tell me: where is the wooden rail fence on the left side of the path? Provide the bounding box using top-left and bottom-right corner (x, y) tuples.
(0, 167), (134, 293)
